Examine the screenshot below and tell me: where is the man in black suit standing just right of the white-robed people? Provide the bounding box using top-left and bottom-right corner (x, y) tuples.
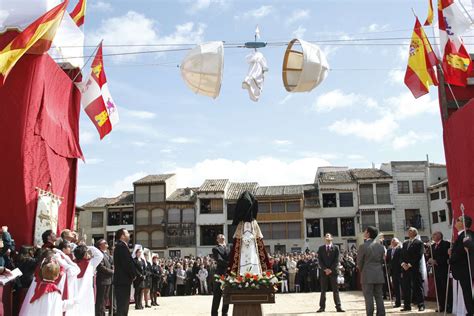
(113, 228), (137, 316)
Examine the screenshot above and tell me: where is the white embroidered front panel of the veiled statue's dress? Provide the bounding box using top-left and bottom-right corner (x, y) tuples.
(239, 222), (262, 275)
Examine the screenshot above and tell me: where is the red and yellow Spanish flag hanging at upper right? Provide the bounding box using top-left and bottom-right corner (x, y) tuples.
(405, 18), (438, 98)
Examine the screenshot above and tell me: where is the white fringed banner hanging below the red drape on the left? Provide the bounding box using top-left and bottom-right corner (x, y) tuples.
(34, 190), (61, 245)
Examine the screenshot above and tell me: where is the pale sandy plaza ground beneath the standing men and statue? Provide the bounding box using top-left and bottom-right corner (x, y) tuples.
(129, 292), (442, 316)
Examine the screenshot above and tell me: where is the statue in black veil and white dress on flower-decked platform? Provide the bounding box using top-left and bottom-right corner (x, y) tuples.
(229, 191), (272, 275)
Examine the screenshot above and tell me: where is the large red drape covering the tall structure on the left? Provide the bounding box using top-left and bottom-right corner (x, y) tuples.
(0, 50), (82, 246)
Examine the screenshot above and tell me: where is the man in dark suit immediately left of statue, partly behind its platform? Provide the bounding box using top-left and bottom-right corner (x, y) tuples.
(211, 234), (229, 316)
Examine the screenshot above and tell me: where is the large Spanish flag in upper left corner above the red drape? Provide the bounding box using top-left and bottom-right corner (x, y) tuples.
(0, 0), (69, 87)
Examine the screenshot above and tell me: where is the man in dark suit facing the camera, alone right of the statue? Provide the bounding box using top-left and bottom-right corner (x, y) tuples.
(317, 233), (344, 313)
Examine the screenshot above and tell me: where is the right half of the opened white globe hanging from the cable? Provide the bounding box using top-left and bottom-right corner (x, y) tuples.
(282, 38), (329, 92)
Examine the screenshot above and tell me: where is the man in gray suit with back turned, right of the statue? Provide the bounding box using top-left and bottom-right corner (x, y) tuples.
(357, 226), (385, 316)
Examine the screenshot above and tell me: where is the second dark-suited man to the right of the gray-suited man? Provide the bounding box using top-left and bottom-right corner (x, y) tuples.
(401, 227), (425, 312)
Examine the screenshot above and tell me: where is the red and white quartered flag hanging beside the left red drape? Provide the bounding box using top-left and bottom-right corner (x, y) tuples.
(77, 43), (119, 139)
